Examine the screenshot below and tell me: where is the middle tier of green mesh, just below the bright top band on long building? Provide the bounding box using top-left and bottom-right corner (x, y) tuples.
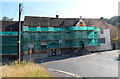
(22, 31), (99, 41)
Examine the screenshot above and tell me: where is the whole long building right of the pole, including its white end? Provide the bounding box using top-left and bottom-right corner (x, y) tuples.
(1, 15), (111, 60)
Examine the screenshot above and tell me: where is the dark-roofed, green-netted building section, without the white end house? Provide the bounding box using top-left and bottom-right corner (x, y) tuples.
(22, 16), (100, 56)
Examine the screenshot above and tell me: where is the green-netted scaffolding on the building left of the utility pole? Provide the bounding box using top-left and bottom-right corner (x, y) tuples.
(0, 31), (18, 55)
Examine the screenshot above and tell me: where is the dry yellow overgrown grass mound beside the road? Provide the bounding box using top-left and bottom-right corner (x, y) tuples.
(0, 61), (52, 79)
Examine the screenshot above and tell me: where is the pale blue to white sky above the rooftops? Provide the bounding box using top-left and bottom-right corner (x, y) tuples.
(0, 0), (119, 21)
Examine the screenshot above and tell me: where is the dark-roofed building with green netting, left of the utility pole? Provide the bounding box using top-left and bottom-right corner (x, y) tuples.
(0, 21), (19, 63)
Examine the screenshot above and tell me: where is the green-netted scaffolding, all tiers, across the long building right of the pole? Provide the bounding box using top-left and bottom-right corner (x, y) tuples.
(22, 26), (100, 49)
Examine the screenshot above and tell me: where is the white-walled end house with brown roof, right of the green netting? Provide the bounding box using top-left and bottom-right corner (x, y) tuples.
(83, 18), (111, 51)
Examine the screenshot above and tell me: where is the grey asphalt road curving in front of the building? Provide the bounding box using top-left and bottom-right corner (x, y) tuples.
(39, 50), (118, 77)
